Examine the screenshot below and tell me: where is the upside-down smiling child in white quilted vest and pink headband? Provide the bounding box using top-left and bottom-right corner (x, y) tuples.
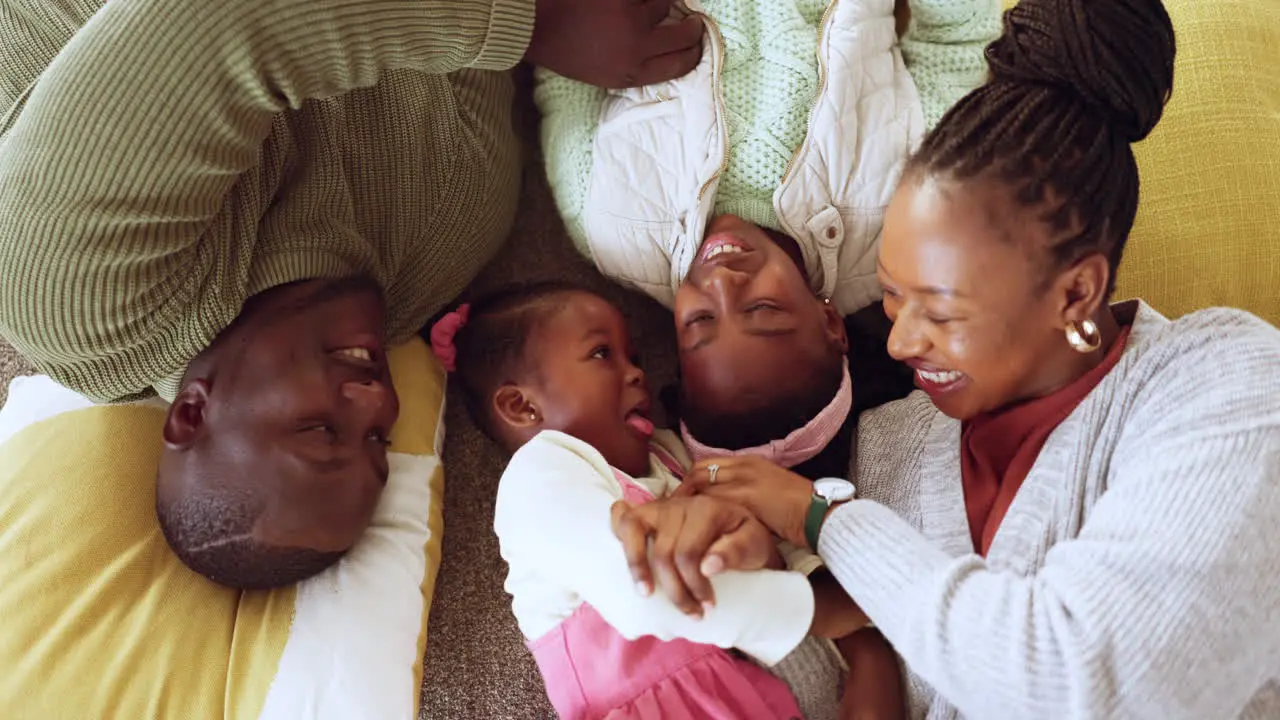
(536, 0), (1001, 477)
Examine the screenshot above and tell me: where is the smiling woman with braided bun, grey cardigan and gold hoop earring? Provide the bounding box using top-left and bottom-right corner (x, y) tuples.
(614, 0), (1280, 719)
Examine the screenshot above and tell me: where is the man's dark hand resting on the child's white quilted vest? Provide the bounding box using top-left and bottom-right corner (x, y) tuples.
(525, 0), (703, 88)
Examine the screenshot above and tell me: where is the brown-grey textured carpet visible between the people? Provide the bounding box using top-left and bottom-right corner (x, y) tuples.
(0, 73), (675, 720)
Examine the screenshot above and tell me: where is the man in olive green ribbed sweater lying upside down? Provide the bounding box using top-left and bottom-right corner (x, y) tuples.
(0, 0), (700, 588)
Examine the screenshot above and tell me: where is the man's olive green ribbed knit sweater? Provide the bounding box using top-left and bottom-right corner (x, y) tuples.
(0, 0), (534, 401)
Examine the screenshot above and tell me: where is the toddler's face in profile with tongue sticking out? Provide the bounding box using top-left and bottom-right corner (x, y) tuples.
(527, 293), (653, 475)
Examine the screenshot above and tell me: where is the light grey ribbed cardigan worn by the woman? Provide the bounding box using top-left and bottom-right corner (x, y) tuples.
(819, 302), (1280, 719)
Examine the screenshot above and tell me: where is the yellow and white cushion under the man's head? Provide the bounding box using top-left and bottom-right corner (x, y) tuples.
(0, 342), (444, 720)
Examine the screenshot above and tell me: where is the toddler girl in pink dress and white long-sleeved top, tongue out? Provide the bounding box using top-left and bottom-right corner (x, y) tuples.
(431, 284), (814, 720)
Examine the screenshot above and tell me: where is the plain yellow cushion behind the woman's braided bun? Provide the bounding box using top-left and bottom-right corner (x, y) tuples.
(1005, 0), (1280, 324)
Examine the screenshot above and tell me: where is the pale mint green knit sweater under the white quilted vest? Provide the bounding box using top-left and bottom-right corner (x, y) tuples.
(536, 0), (1001, 242)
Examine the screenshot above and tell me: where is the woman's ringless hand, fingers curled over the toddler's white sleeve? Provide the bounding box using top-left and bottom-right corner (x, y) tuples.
(613, 496), (777, 616)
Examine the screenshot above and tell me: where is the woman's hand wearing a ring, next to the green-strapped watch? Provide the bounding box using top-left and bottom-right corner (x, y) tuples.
(673, 455), (813, 545)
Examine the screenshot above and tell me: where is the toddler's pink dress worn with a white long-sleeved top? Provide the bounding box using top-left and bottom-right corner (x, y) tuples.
(529, 452), (800, 720)
